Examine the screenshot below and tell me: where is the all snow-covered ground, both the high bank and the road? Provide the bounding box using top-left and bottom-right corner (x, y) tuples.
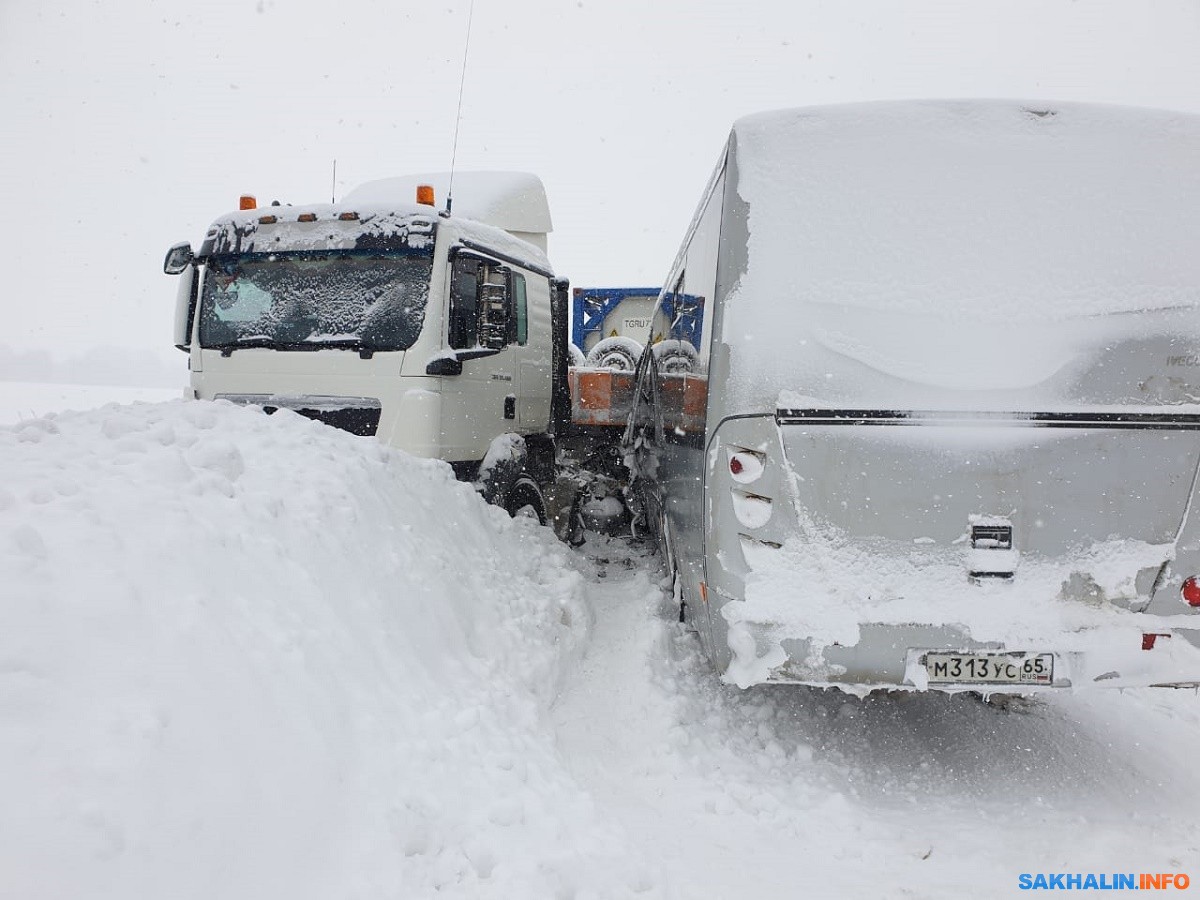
(0, 391), (1200, 900)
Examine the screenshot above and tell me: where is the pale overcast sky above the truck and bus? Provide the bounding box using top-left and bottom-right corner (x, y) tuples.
(0, 0), (1200, 374)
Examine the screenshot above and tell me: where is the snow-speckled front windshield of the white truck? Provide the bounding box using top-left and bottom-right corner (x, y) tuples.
(200, 250), (433, 350)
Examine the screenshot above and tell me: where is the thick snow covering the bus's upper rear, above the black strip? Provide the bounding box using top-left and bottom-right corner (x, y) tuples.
(726, 101), (1200, 407)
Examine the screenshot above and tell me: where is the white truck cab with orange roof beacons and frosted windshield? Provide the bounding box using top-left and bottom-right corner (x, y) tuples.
(164, 173), (570, 511)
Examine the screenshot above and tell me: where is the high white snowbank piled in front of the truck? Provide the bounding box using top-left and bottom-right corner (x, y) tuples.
(0, 401), (631, 900)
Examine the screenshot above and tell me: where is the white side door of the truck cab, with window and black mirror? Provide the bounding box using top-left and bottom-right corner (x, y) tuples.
(442, 251), (517, 462)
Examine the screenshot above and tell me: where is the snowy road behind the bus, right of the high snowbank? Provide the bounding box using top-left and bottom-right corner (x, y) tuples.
(554, 541), (1200, 900)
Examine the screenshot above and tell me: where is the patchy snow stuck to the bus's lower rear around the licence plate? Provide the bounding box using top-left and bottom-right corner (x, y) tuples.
(721, 522), (1200, 695)
